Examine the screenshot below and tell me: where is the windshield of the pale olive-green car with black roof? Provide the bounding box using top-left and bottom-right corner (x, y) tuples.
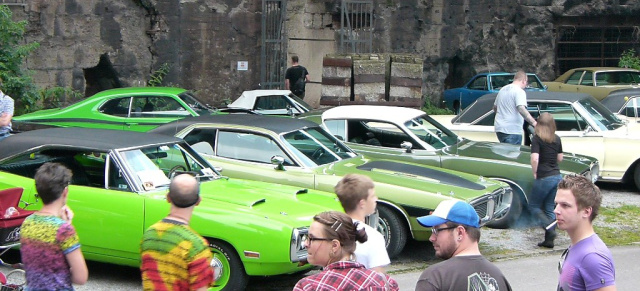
(281, 127), (357, 167)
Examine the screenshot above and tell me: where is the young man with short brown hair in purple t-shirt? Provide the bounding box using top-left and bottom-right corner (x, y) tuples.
(554, 176), (616, 291)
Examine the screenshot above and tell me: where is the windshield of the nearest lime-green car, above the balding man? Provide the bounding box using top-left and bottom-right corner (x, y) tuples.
(120, 144), (220, 191)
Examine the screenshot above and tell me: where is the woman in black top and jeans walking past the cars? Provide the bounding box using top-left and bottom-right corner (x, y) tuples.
(529, 113), (562, 248)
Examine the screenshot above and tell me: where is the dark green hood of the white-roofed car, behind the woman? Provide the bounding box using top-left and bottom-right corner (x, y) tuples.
(442, 139), (597, 173)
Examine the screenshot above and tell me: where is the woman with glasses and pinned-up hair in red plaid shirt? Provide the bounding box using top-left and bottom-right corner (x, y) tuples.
(293, 211), (399, 291)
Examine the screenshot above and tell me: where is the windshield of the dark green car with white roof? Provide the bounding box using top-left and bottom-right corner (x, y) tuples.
(404, 115), (458, 149)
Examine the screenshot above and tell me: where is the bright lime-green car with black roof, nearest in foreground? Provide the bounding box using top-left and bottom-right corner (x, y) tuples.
(0, 128), (342, 290)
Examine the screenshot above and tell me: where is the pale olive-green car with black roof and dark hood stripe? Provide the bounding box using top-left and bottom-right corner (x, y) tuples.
(151, 114), (512, 257)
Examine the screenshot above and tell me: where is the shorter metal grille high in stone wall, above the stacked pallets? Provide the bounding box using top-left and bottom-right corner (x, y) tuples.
(340, 0), (373, 53)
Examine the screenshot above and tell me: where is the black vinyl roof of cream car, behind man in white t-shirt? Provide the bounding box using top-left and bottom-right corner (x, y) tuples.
(452, 91), (595, 123)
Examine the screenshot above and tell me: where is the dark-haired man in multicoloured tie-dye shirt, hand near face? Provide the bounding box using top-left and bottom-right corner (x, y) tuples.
(20, 163), (89, 291)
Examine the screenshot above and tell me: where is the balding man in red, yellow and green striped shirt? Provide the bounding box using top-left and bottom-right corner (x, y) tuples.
(140, 174), (213, 290)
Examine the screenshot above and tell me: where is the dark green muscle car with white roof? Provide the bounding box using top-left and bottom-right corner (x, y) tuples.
(300, 105), (599, 228)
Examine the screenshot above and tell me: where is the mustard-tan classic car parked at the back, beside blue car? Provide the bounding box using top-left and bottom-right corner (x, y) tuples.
(542, 67), (640, 100)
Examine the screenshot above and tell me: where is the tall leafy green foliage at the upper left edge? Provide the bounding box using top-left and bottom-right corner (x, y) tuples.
(0, 5), (40, 115)
